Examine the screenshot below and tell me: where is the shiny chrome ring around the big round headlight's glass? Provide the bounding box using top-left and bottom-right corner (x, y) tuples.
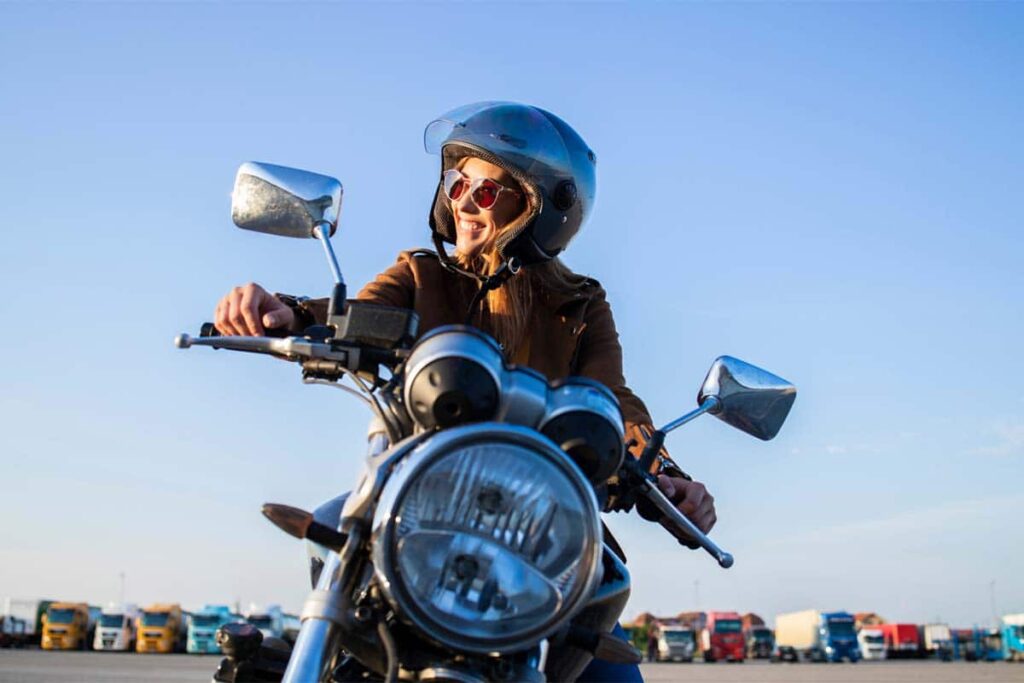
(371, 423), (603, 654)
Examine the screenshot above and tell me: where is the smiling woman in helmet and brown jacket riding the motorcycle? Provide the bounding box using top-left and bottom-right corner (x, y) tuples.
(214, 102), (716, 680)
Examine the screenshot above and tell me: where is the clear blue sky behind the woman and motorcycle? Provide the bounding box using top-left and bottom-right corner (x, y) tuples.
(0, 2), (1024, 625)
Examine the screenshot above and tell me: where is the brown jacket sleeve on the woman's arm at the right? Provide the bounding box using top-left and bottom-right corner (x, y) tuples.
(574, 290), (689, 479)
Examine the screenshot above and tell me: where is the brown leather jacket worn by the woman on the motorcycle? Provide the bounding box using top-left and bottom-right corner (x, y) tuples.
(296, 251), (678, 470)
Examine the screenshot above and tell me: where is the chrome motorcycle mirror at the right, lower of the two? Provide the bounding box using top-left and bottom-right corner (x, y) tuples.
(697, 355), (797, 441)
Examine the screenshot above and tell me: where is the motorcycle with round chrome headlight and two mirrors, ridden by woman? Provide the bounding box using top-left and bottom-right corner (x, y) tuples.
(175, 162), (796, 683)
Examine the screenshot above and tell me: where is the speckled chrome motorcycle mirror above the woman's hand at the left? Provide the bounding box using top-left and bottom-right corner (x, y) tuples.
(231, 162), (342, 238)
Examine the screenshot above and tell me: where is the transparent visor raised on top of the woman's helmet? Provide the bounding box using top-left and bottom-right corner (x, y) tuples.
(423, 101), (572, 178)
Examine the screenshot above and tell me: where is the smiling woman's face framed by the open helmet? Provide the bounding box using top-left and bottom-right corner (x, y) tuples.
(450, 157), (523, 257)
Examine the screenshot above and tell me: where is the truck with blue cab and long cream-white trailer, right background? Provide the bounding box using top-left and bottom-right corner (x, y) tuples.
(775, 609), (860, 661)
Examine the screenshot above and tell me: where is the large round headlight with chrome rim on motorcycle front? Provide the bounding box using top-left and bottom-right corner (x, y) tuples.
(373, 424), (601, 653)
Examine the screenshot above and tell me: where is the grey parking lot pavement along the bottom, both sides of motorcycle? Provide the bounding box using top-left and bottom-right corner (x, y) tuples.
(0, 650), (1024, 683)
